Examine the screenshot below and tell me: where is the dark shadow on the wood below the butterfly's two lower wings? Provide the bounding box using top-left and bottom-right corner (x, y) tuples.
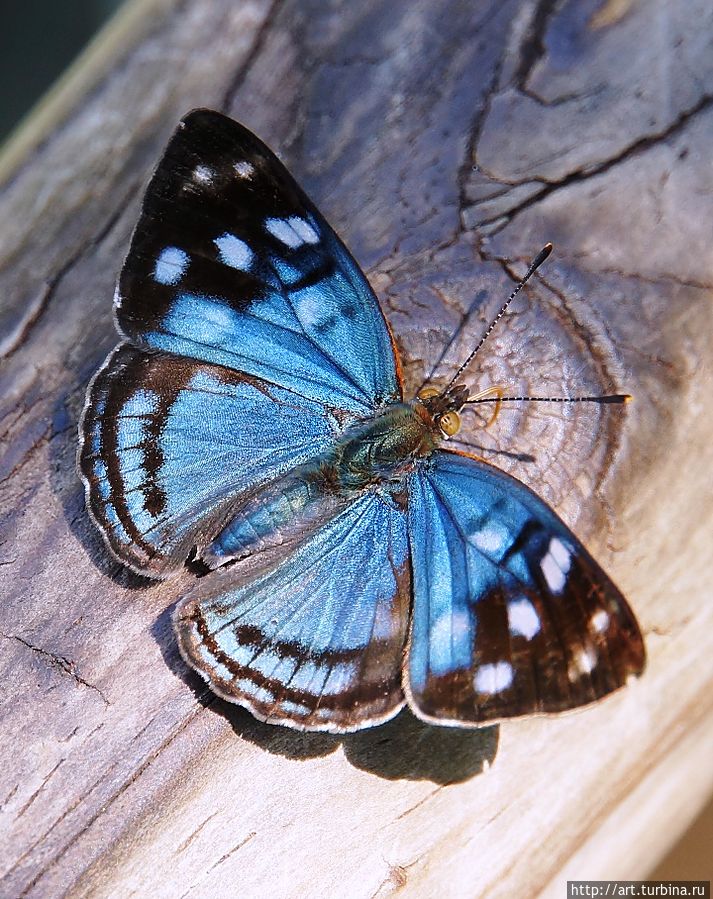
(152, 607), (499, 785)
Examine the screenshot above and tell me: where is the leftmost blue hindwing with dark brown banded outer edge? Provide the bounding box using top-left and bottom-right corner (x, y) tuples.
(79, 344), (339, 577)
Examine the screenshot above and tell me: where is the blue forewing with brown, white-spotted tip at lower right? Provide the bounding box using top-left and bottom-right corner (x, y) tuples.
(405, 452), (645, 726)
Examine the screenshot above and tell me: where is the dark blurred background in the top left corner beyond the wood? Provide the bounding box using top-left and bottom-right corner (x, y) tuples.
(0, 0), (122, 141)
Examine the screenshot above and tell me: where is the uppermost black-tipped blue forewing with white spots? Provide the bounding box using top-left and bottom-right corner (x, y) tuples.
(116, 109), (401, 416)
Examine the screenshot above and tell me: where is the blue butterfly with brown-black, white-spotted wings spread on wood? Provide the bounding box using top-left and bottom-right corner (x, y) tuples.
(78, 109), (645, 733)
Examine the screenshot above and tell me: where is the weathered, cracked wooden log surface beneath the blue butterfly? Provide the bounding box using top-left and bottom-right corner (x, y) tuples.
(0, 0), (713, 897)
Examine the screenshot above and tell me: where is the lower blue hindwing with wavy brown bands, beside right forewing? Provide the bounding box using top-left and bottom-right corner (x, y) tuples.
(175, 493), (410, 732)
